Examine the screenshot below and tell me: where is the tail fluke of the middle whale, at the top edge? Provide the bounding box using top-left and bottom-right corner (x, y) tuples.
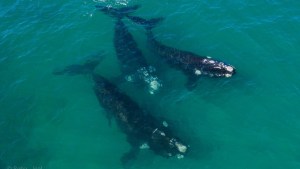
(95, 5), (140, 18)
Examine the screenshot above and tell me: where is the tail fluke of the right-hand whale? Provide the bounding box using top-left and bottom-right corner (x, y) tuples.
(127, 15), (164, 31)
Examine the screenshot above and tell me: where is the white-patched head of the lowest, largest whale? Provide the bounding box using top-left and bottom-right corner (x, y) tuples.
(150, 129), (189, 158)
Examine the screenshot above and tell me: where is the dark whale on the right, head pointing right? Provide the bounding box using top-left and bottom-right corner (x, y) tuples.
(126, 14), (236, 89)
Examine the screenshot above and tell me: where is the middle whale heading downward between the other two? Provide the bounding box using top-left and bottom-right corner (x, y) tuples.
(96, 5), (162, 94)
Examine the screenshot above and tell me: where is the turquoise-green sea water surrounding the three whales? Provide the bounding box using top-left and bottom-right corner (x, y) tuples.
(0, 0), (300, 169)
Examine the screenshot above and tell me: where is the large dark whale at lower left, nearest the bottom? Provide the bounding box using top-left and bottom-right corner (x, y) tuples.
(53, 59), (190, 167)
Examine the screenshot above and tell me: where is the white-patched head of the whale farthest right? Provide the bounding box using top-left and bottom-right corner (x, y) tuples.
(194, 57), (236, 77)
